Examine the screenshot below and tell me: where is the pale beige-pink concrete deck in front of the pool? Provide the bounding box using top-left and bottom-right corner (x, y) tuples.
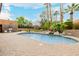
(0, 32), (79, 56)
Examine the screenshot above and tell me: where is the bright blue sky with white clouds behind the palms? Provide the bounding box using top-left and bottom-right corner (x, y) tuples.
(0, 3), (79, 22)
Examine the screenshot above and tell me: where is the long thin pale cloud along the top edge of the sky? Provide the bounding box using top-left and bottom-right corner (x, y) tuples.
(10, 3), (43, 9)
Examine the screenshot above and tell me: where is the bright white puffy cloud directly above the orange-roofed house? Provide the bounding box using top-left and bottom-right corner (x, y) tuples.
(0, 3), (13, 20)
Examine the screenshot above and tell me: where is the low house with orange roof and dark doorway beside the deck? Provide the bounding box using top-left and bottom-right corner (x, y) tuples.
(0, 19), (18, 32)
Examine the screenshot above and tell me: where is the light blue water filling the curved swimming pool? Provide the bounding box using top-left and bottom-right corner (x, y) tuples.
(21, 33), (78, 44)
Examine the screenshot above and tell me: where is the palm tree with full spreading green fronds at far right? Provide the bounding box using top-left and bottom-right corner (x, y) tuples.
(65, 3), (79, 28)
